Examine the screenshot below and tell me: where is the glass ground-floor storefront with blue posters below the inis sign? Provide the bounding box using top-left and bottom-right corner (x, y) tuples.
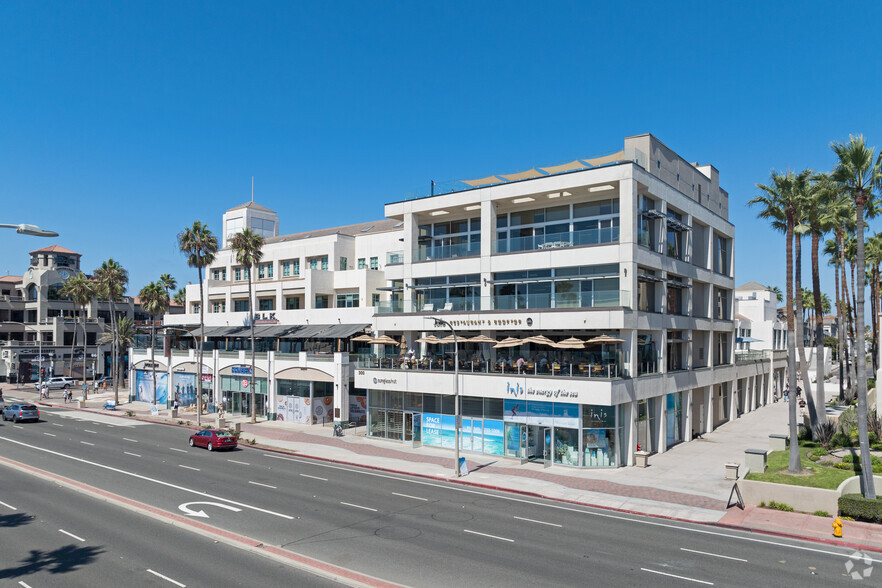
(367, 389), (624, 467)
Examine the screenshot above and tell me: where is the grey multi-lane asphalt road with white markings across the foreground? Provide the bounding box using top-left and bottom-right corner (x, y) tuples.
(0, 400), (882, 588)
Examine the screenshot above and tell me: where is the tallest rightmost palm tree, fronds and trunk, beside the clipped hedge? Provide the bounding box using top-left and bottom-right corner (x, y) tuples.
(830, 135), (882, 500)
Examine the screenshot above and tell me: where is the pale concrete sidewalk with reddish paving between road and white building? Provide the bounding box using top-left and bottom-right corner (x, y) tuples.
(4, 389), (882, 551)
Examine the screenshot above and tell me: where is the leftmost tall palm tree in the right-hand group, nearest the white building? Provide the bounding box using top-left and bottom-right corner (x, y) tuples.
(748, 171), (802, 474)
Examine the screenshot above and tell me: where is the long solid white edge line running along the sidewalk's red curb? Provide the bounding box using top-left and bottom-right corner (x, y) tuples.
(258, 450), (882, 563)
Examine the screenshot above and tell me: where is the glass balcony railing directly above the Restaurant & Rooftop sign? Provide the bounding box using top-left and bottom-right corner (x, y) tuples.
(375, 290), (631, 314)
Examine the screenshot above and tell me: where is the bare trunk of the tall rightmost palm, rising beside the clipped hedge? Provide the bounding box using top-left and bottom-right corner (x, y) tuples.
(855, 195), (876, 500)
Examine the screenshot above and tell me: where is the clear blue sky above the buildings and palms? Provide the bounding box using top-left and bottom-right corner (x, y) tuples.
(0, 0), (882, 298)
